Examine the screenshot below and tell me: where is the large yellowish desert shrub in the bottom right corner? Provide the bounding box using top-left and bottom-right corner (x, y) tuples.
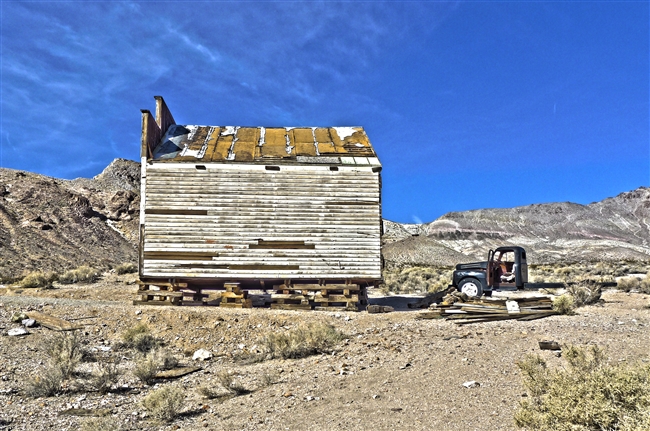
(514, 346), (650, 431)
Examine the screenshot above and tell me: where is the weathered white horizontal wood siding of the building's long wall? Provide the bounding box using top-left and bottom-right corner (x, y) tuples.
(142, 162), (381, 280)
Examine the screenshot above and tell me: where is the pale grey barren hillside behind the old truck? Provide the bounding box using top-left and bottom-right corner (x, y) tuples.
(384, 187), (650, 265)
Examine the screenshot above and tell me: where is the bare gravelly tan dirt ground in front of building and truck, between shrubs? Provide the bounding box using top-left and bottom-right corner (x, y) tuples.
(0, 274), (650, 431)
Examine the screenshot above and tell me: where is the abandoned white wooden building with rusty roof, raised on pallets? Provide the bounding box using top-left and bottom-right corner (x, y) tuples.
(138, 96), (382, 309)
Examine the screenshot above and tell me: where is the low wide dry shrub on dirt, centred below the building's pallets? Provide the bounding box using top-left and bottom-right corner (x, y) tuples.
(261, 323), (345, 359)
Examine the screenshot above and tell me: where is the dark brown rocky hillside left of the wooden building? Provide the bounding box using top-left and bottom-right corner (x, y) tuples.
(0, 159), (140, 280)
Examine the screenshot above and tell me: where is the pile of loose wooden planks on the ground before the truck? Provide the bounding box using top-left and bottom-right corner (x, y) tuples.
(418, 297), (559, 325)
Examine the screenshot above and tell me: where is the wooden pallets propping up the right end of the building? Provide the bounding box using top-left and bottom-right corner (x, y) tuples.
(271, 284), (366, 311)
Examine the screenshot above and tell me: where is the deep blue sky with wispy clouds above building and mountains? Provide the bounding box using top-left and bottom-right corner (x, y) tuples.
(0, 1), (650, 222)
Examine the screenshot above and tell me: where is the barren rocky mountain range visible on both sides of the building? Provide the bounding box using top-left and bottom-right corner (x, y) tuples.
(0, 159), (650, 280)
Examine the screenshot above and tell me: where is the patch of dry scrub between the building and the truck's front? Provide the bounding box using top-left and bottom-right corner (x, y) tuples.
(382, 266), (453, 293)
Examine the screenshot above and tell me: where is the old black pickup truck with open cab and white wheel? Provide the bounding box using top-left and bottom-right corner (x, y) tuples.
(450, 246), (564, 297)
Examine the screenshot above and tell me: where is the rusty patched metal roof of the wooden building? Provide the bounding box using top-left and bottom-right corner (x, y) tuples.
(153, 124), (381, 166)
